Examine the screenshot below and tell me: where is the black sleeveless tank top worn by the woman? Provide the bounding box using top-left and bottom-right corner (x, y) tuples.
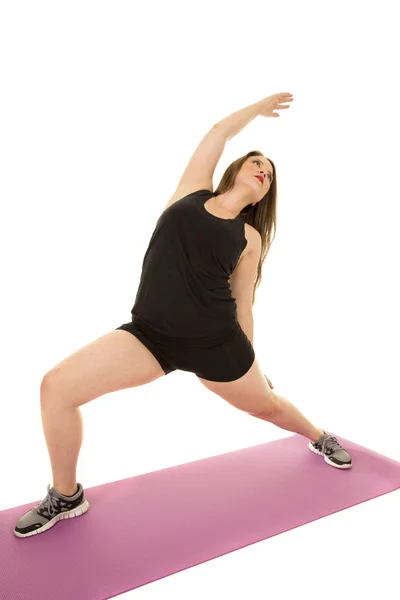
(131, 190), (247, 339)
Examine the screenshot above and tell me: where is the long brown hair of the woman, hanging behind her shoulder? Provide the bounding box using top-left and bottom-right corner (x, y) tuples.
(214, 150), (277, 306)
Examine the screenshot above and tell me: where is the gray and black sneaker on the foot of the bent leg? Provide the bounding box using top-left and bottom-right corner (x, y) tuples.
(14, 483), (89, 537)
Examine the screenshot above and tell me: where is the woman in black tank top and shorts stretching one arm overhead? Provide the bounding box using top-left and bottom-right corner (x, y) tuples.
(14, 93), (351, 537)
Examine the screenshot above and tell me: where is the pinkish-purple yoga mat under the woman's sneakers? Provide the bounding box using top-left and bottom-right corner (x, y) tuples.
(0, 435), (400, 600)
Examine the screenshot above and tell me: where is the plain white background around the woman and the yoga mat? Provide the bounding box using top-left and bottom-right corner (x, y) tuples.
(0, 1), (400, 600)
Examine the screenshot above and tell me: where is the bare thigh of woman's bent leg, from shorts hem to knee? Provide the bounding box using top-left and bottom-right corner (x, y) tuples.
(40, 329), (165, 406)
